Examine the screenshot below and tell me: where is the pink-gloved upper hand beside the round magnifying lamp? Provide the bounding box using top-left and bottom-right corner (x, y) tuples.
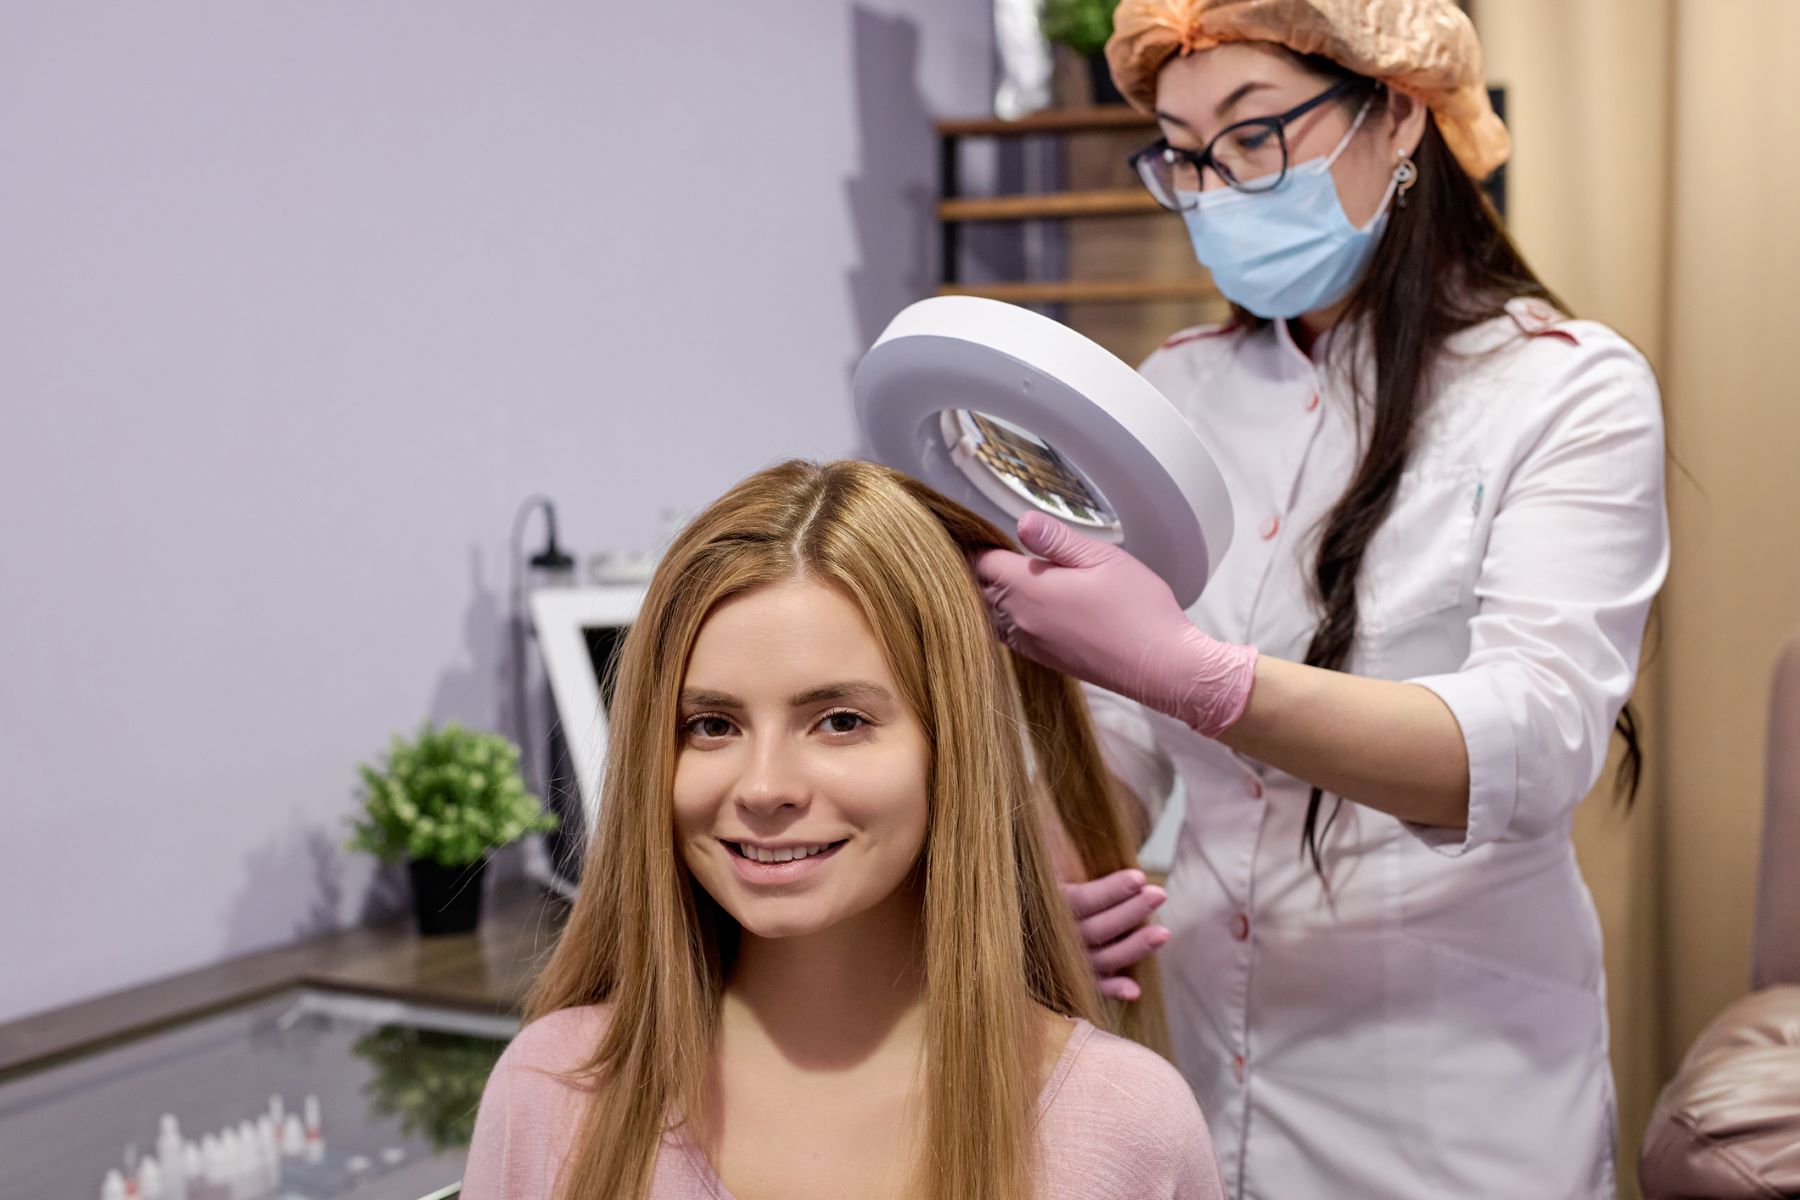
(976, 513), (1256, 738)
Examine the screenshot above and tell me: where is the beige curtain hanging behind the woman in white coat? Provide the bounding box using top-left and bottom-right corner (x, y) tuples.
(1472, 0), (1800, 1196)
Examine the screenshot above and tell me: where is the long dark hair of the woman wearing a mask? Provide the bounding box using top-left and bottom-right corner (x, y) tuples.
(1233, 56), (1643, 878)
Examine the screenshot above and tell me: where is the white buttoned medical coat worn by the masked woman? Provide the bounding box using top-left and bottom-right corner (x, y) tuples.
(1089, 300), (1669, 1200)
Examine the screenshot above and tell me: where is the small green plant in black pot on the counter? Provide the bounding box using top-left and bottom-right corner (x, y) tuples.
(346, 721), (556, 936)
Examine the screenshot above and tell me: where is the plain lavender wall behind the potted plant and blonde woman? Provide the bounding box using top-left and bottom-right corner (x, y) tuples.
(0, 0), (992, 1020)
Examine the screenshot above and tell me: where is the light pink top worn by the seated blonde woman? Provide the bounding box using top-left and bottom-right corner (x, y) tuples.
(463, 1006), (1224, 1200)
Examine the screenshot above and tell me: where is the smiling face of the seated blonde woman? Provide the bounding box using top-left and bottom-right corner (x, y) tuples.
(675, 579), (931, 937)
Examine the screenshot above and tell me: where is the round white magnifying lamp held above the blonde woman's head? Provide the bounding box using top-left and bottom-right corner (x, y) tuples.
(851, 295), (1231, 608)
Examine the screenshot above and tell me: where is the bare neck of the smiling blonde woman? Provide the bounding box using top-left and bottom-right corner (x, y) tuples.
(722, 887), (925, 1070)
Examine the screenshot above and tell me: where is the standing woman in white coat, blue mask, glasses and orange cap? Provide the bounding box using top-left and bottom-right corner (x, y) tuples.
(977, 0), (1669, 1200)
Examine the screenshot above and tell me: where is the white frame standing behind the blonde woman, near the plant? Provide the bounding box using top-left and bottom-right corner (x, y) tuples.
(527, 583), (648, 892)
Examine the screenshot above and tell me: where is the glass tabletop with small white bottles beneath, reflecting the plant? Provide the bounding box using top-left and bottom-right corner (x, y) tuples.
(0, 988), (518, 1200)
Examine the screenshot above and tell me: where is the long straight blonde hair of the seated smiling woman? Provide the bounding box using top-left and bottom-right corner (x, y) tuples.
(526, 462), (1163, 1200)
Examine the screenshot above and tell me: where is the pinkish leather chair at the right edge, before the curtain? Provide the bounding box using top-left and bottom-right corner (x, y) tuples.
(1638, 635), (1800, 1200)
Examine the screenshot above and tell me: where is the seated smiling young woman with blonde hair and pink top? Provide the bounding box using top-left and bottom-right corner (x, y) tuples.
(464, 462), (1220, 1200)
